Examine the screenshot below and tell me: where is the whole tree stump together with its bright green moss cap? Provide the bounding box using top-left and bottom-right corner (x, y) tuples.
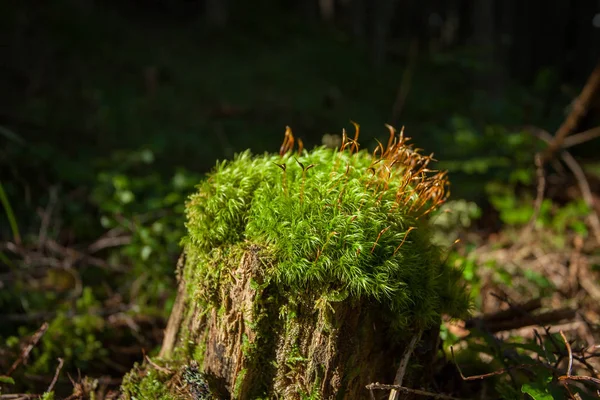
(119, 126), (469, 399)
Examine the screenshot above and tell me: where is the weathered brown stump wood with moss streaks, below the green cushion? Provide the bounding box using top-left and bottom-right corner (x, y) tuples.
(160, 245), (438, 399)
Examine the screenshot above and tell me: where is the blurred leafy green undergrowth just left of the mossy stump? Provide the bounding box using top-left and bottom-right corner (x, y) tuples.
(92, 149), (199, 314)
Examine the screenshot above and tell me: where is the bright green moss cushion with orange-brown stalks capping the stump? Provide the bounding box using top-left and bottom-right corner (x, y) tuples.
(184, 124), (469, 331)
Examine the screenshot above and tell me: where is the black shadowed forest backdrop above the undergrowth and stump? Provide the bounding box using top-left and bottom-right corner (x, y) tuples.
(0, 0), (600, 172)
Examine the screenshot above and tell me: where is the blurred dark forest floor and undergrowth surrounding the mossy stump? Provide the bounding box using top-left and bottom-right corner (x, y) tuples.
(0, 0), (600, 399)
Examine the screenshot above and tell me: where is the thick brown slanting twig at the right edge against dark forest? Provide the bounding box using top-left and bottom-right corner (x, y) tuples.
(542, 62), (600, 163)
